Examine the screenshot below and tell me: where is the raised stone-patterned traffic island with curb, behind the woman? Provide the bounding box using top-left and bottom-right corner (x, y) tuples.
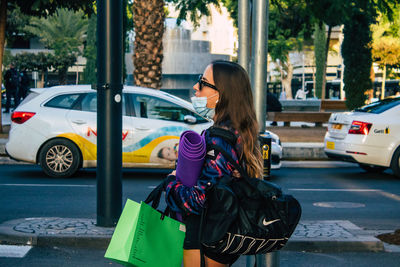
(0, 218), (390, 252)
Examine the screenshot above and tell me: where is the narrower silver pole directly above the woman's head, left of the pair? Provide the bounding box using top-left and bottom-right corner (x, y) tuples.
(238, 0), (250, 72)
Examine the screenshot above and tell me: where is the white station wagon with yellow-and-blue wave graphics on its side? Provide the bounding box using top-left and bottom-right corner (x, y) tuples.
(6, 85), (282, 177)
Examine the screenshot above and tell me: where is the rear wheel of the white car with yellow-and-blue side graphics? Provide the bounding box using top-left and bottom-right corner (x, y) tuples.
(39, 139), (81, 177)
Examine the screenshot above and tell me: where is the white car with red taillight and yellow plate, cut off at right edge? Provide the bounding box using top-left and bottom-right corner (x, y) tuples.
(324, 97), (400, 177)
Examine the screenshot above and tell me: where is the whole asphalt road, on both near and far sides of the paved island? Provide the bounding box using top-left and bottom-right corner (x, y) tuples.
(0, 165), (400, 267)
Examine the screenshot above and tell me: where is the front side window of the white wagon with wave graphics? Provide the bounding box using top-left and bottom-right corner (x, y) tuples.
(134, 95), (208, 123)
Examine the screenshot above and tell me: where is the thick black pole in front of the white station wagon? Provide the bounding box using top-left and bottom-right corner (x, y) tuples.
(97, 0), (123, 227)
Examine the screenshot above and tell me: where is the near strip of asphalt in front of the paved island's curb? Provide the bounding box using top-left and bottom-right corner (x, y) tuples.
(0, 245), (400, 267)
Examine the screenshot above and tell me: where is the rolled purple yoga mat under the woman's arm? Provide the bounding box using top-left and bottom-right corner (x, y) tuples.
(176, 131), (206, 186)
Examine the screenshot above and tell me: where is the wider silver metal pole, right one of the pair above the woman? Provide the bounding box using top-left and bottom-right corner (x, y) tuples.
(251, 0), (269, 132)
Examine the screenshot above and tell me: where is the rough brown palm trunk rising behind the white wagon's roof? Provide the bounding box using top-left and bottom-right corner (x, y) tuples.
(133, 0), (165, 89)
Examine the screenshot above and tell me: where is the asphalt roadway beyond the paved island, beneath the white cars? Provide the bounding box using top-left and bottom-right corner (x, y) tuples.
(0, 165), (400, 230)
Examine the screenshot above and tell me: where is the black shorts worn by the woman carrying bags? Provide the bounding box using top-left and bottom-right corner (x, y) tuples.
(183, 214), (239, 265)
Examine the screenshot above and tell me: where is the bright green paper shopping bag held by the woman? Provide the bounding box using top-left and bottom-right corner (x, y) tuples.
(104, 199), (185, 267)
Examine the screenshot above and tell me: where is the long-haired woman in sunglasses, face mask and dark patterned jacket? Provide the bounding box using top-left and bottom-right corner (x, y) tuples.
(166, 61), (262, 267)
